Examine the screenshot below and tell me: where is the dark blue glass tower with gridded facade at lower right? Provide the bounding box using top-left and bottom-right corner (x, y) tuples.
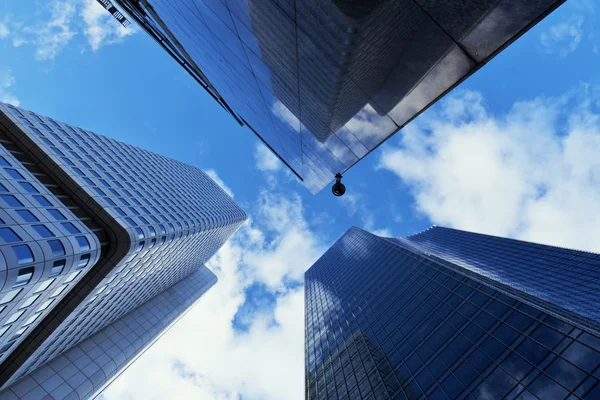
(305, 227), (600, 400)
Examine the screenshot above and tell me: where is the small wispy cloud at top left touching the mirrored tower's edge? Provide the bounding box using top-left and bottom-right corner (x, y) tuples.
(80, 0), (137, 51)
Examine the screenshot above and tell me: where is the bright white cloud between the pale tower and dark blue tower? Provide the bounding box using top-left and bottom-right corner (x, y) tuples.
(103, 188), (325, 400)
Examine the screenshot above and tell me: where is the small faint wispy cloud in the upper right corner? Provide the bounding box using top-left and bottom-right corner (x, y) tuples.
(540, 16), (583, 57)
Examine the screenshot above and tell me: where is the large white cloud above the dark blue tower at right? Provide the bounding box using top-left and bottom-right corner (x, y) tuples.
(379, 86), (600, 251)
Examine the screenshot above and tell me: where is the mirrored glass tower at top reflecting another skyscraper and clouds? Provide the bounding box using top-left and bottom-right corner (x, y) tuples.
(113, 0), (564, 193)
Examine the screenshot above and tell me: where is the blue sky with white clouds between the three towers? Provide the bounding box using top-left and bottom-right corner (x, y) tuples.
(0, 0), (600, 399)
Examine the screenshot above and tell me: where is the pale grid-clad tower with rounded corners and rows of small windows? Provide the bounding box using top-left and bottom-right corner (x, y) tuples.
(0, 103), (246, 399)
